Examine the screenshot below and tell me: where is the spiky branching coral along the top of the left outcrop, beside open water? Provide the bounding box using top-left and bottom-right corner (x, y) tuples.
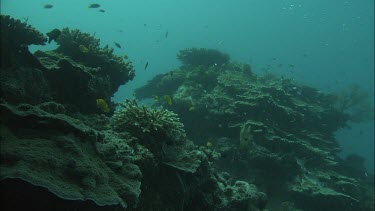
(56, 28), (135, 92)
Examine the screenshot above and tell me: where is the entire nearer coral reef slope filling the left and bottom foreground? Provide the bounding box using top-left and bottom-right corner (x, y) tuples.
(0, 16), (267, 211)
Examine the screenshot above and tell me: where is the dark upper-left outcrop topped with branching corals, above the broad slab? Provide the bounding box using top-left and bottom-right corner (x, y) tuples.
(0, 16), (135, 114)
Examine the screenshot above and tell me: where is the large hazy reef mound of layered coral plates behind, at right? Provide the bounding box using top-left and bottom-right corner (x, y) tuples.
(136, 54), (373, 210)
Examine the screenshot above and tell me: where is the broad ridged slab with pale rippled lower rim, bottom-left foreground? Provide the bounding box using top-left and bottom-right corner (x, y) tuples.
(0, 104), (140, 207)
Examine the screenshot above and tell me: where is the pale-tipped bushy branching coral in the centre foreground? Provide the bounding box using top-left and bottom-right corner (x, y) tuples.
(113, 99), (186, 141)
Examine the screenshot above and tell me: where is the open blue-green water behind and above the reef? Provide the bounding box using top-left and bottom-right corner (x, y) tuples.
(1, 0), (374, 171)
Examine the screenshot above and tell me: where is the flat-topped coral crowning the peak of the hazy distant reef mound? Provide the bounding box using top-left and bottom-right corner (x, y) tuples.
(177, 48), (229, 67)
